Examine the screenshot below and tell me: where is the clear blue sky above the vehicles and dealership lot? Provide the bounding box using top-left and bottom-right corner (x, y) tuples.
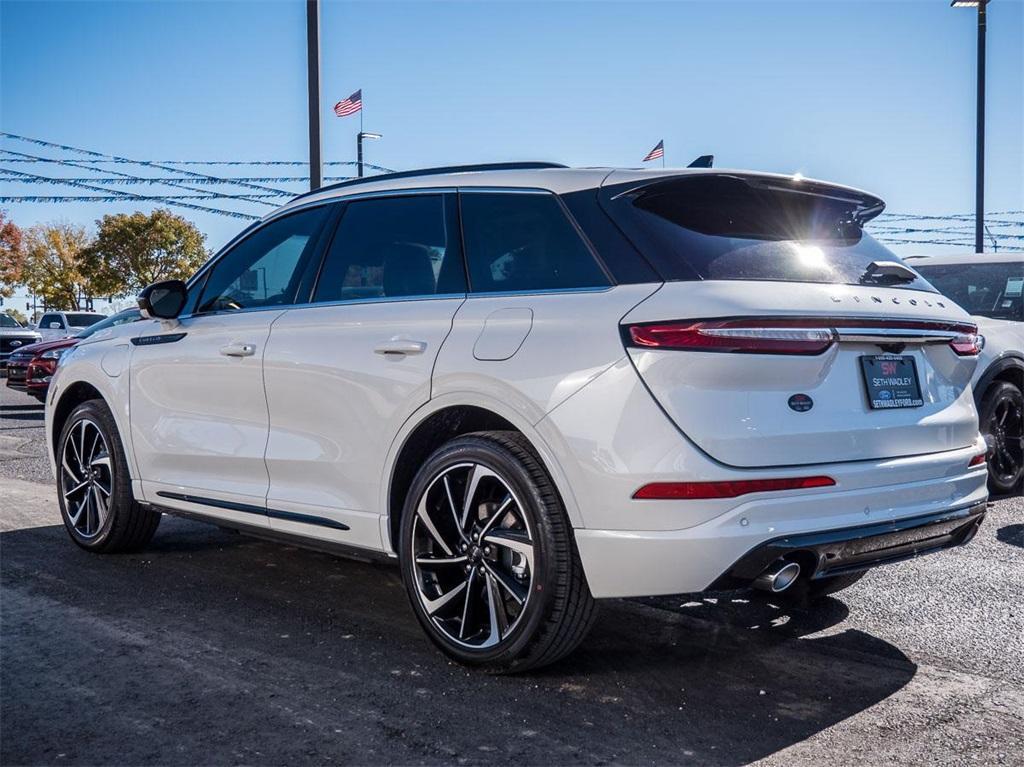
(0, 0), (1024, 266)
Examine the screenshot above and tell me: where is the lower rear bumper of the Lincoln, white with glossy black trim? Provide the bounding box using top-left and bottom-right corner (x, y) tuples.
(575, 450), (988, 598)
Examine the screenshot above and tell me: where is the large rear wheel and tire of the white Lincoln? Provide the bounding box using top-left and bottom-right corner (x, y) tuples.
(399, 431), (596, 673)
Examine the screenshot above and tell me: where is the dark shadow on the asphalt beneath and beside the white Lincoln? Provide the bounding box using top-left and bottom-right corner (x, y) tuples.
(0, 517), (916, 765)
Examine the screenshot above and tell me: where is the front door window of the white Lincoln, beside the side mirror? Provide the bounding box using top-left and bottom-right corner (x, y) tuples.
(197, 205), (329, 312)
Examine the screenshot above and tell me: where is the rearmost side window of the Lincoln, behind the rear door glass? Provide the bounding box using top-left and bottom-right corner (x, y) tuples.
(460, 191), (608, 293)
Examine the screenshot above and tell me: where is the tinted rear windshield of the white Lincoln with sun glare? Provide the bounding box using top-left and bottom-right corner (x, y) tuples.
(602, 175), (934, 292)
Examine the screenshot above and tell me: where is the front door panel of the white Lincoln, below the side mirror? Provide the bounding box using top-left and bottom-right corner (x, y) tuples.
(131, 309), (282, 525)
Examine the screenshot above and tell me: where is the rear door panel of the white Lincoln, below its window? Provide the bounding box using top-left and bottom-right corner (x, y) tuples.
(264, 297), (464, 549)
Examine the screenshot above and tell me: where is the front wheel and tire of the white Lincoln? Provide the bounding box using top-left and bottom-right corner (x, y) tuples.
(56, 399), (161, 554)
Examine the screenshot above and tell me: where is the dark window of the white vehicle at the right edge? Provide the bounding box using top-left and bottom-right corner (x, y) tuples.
(911, 261), (1024, 319)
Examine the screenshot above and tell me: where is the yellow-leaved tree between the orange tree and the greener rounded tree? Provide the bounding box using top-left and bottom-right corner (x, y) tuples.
(20, 221), (94, 311)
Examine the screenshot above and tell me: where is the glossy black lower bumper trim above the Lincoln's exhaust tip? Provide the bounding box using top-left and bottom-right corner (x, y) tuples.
(711, 503), (988, 590)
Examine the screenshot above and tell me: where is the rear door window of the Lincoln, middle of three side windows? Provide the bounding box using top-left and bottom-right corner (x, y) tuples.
(313, 195), (466, 302)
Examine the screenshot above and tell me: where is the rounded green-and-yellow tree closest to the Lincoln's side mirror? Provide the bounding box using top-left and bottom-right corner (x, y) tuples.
(83, 208), (209, 296)
